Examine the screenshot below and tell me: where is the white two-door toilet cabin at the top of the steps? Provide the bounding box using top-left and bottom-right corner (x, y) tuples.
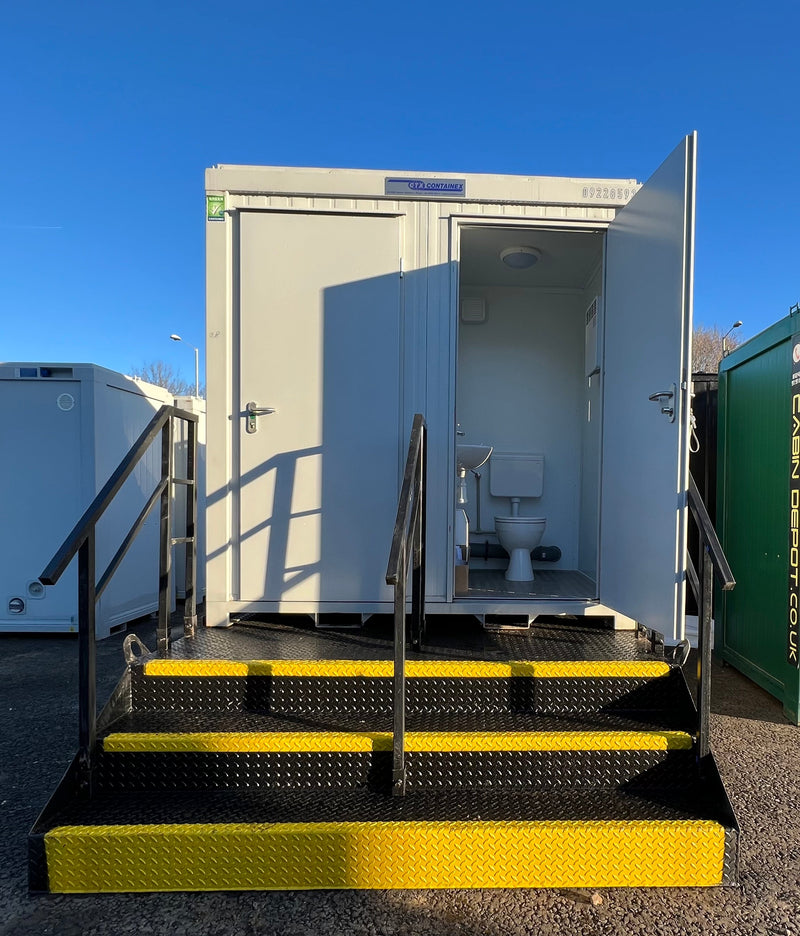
(206, 134), (696, 639)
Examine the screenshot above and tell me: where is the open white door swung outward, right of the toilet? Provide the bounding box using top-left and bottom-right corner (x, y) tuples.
(599, 134), (697, 640)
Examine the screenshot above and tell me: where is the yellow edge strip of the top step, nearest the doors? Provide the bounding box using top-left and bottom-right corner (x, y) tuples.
(144, 660), (669, 679)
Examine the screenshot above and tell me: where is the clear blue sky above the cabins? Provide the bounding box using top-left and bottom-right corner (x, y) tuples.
(0, 0), (800, 388)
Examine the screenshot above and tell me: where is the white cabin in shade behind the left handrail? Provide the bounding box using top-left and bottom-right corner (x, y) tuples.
(0, 362), (173, 637)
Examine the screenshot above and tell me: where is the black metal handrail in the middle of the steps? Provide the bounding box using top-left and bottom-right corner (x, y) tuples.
(386, 413), (428, 796)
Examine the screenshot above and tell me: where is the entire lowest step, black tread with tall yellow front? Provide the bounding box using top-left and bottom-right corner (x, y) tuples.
(42, 783), (735, 892)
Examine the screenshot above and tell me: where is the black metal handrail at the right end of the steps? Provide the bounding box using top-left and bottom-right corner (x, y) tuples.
(686, 474), (736, 761)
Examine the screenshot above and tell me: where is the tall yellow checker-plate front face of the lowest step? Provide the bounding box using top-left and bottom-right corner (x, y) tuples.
(45, 820), (725, 893)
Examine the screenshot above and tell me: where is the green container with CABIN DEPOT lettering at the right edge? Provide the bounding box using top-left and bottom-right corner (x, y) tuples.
(715, 313), (800, 724)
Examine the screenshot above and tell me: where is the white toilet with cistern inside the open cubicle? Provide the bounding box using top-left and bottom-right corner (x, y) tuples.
(489, 452), (546, 582)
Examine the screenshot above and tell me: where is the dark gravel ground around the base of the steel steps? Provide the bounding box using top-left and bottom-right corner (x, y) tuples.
(0, 621), (800, 936)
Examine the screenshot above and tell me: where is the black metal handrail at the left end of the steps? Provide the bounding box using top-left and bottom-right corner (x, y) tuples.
(39, 406), (198, 793)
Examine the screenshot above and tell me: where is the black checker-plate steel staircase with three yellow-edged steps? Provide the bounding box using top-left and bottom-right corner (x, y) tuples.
(29, 417), (738, 892)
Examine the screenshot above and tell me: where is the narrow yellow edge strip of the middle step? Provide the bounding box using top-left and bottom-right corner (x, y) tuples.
(103, 731), (692, 753)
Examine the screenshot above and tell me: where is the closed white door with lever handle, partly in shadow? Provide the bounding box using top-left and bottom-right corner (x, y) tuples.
(234, 212), (401, 610)
